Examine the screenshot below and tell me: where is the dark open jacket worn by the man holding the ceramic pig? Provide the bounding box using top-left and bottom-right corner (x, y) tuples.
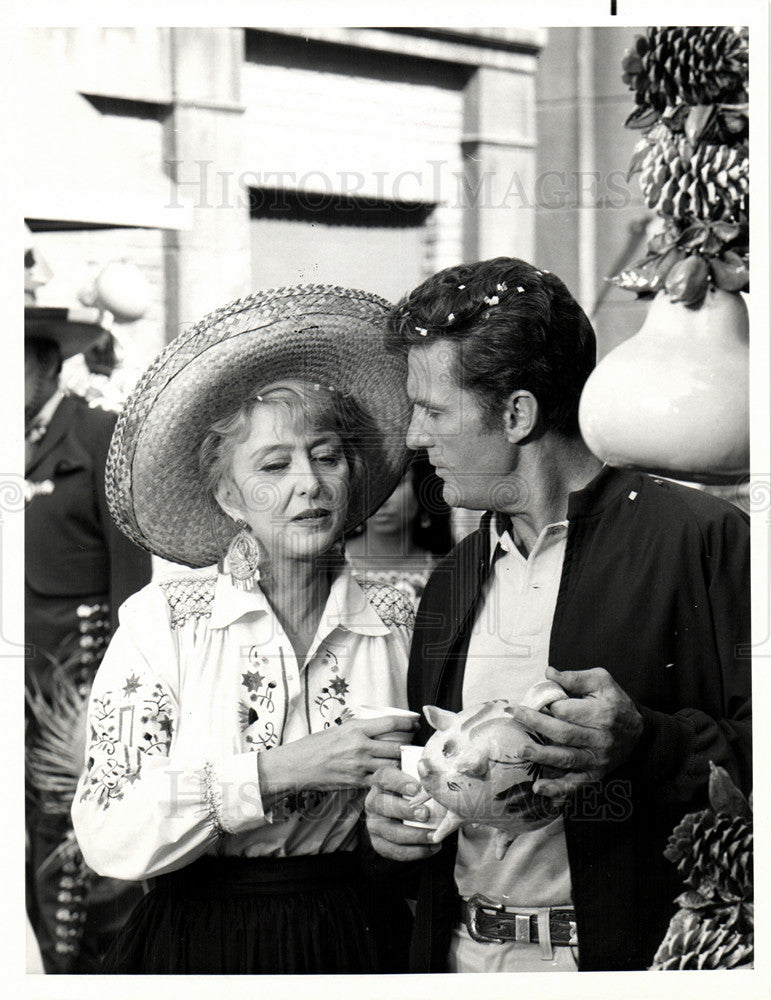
(408, 468), (752, 972)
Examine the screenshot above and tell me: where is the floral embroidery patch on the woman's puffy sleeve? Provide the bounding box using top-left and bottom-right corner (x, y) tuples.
(80, 673), (174, 809)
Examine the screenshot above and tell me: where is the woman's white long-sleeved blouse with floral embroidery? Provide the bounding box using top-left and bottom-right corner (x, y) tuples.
(72, 568), (413, 879)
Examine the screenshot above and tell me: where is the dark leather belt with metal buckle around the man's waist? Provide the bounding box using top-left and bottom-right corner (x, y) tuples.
(461, 893), (578, 959)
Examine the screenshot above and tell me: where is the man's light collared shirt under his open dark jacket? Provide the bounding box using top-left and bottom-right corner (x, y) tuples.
(455, 519), (571, 912)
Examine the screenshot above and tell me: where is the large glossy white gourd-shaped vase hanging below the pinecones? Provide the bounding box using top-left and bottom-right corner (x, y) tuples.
(579, 289), (749, 483)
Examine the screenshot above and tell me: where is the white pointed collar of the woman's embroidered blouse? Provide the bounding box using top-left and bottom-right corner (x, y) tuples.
(209, 566), (391, 639)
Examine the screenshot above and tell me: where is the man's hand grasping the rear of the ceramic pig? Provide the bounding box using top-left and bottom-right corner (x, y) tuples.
(514, 667), (643, 799)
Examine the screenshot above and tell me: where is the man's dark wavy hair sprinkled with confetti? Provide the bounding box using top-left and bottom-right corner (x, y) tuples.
(388, 257), (596, 437)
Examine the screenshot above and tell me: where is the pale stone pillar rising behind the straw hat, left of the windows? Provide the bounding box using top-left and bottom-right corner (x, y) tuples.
(164, 28), (250, 340)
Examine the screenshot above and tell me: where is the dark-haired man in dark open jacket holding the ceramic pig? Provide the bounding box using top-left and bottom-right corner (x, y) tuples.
(367, 258), (751, 972)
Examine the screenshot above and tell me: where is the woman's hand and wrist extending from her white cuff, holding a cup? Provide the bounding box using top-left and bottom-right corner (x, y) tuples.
(258, 715), (417, 808)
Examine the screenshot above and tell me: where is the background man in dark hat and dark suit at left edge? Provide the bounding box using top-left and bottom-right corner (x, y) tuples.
(24, 305), (151, 972)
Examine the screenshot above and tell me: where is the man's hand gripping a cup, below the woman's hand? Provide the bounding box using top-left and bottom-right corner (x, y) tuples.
(365, 766), (441, 861)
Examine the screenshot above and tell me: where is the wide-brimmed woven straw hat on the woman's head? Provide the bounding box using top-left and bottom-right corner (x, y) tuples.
(106, 285), (410, 566)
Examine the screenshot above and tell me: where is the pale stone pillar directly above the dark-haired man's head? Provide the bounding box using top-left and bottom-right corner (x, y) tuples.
(462, 64), (537, 261)
